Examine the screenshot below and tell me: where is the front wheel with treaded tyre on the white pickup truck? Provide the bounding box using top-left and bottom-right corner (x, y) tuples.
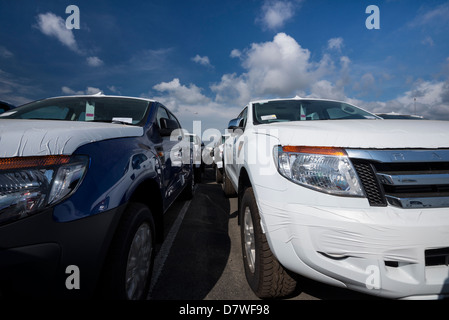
(240, 188), (296, 299)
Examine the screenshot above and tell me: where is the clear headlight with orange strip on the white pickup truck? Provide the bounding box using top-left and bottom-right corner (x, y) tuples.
(274, 146), (365, 197)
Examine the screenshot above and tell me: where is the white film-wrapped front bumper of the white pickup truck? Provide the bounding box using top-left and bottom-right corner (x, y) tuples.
(255, 184), (449, 299)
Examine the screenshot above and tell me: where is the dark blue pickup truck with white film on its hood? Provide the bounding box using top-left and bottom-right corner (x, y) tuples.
(0, 95), (194, 300)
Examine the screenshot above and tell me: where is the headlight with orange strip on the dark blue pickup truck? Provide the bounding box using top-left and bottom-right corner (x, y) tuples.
(0, 156), (88, 224)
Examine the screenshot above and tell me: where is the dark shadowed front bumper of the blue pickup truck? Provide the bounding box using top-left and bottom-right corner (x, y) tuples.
(0, 207), (124, 299)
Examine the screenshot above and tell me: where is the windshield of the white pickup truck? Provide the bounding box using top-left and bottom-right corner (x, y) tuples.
(254, 100), (380, 124)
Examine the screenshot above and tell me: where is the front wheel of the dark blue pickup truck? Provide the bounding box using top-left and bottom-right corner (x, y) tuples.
(101, 203), (155, 300)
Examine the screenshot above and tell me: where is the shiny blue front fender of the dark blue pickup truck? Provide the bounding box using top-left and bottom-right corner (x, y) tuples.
(53, 138), (163, 222)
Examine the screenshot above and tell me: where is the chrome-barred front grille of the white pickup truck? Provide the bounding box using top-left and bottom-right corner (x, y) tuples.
(347, 150), (449, 208)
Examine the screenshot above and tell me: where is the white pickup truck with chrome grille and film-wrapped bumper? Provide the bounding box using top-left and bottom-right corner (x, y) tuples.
(223, 97), (449, 299)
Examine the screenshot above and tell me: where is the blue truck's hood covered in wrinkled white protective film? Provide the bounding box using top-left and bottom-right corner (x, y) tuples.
(0, 119), (143, 158)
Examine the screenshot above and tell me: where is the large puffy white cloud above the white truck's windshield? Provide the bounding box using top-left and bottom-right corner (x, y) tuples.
(211, 33), (332, 104)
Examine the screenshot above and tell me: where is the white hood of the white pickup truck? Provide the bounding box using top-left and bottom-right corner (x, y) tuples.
(256, 120), (449, 149)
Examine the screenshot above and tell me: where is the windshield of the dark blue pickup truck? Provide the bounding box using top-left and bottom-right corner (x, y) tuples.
(0, 97), (149, 125)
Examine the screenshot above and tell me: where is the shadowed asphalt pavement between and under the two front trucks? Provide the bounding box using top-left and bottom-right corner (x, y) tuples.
(148, 167), (373, 301)
